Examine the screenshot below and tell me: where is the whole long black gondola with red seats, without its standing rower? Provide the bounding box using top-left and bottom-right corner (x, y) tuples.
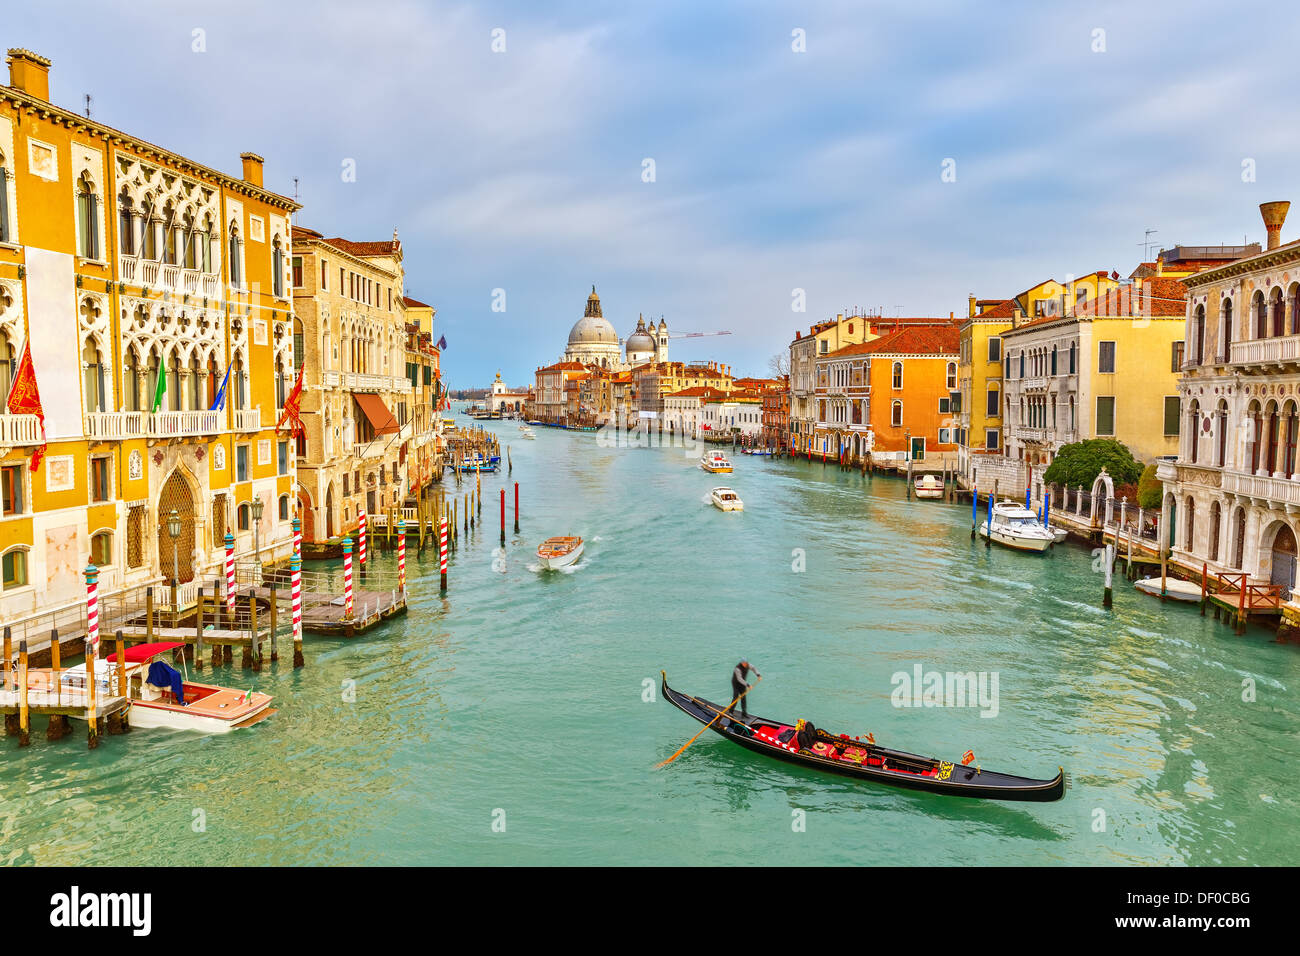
(660, 671), (1066, 803)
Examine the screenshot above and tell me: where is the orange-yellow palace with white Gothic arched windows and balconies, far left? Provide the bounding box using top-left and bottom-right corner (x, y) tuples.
(0, 49), (298, 622)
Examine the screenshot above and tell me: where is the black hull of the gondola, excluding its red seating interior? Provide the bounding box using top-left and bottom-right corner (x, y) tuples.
(663, 675), (1066, 803)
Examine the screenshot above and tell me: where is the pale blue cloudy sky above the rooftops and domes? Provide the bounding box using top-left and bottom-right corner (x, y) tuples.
(10, 0), (1300, 388)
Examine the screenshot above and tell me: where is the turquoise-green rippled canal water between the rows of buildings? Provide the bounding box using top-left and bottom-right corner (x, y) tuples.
(0, 423), (1300, 865)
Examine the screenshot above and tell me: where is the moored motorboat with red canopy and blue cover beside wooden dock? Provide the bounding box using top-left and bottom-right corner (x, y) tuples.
(27, 641), (276, 734)
